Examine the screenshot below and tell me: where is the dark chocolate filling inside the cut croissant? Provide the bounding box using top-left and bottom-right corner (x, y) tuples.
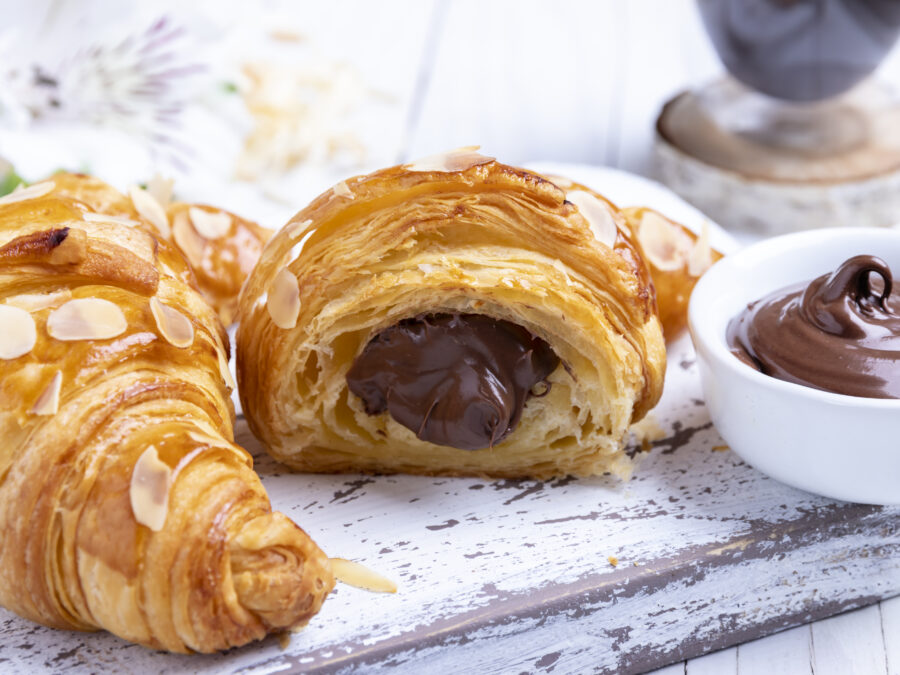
(347, 314), (559, 450)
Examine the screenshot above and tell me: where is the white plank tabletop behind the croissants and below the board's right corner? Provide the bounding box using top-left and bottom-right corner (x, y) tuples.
(0, 0), (900, 675)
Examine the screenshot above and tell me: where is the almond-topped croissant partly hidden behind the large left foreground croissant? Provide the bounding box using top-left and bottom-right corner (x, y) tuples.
(45, 172), (272, 326)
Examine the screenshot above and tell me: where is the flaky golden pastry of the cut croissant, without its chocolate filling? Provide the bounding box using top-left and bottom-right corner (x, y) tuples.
(238, 153), (665, 478)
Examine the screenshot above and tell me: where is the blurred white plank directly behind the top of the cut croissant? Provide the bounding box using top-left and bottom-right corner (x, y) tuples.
(406, 0), (624, 164)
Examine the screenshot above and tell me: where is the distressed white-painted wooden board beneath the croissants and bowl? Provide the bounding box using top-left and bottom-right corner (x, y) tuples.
(0, 338), (900, 674)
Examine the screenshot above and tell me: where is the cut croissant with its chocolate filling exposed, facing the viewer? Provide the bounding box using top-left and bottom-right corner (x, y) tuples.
(237, 149), (696, 479)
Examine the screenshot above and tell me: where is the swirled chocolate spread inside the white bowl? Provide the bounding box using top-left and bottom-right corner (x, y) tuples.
(728, 255), (900, 398)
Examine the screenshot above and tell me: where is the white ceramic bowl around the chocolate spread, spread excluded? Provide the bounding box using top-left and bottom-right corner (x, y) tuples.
(689, 228), (900, 504)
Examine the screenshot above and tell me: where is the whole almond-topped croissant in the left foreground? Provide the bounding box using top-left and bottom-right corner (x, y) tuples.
(0, 182), (334, 652)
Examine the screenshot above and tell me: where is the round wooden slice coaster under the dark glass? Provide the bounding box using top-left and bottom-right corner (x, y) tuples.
(655, 85), (900, 235)
